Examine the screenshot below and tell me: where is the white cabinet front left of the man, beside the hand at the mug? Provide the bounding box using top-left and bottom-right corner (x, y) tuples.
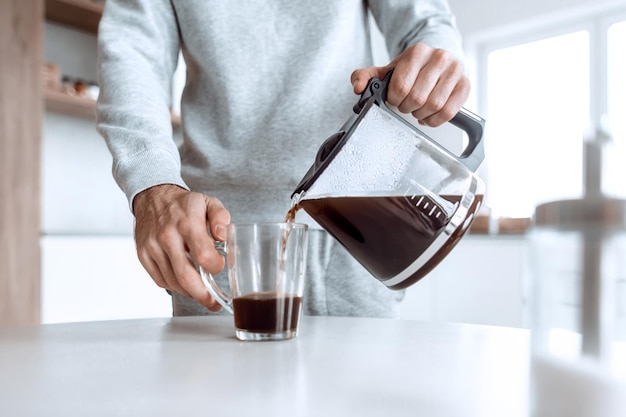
(41, 236), (172, 323)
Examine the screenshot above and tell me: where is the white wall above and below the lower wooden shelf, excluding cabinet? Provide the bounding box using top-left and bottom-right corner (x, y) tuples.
(42, 24), (133, 235)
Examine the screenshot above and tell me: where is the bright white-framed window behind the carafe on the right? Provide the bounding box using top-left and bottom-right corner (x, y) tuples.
(478, 10), (626, 217)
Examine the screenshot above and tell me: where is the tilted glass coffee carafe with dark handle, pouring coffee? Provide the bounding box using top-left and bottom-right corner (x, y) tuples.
(292, 71), (484, 289)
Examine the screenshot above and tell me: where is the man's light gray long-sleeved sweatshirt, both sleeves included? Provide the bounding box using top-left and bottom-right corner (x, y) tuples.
(97, 0), (462, 221)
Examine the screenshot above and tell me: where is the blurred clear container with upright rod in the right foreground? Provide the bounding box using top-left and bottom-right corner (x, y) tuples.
(529, 127), (626, 417)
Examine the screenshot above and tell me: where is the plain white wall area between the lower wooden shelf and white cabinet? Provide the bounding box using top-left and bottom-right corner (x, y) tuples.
(41, 112), (133, 235)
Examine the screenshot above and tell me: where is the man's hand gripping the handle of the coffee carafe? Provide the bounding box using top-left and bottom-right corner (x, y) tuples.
(350, 43), (470, 127)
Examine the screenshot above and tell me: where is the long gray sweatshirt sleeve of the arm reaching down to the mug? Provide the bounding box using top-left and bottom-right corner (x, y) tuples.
(96, 0), (188, 207)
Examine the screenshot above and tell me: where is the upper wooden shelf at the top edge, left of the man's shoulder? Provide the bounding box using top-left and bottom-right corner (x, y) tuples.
(46, 0), (104, 34)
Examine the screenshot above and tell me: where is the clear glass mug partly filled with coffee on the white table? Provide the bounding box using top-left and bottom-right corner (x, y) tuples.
(199, 222), (308, 340)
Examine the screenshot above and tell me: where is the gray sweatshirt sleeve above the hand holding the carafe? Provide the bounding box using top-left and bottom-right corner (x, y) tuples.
(368, 0), (464, 62)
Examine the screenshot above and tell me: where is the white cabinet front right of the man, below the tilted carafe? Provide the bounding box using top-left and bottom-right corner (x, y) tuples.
(401, 235), (526, 327)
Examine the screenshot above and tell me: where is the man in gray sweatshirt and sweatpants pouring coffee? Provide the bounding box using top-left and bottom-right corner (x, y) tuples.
(97, 0), (470, 317)
